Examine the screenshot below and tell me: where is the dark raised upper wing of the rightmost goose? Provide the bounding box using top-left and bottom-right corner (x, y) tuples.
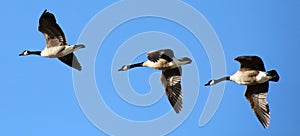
(234, 56), (266, 71)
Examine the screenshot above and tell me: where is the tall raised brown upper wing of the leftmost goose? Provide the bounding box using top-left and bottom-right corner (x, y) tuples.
(38, 10), (67, 48)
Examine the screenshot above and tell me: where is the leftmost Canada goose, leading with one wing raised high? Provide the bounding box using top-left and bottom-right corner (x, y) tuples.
(19, 9), (85, 71)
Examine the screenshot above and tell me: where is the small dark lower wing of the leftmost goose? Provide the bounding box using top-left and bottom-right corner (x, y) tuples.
(58, 53), (81, 71)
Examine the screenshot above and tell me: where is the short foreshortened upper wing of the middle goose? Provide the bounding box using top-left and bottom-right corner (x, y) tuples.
(147, 49), (174, 62)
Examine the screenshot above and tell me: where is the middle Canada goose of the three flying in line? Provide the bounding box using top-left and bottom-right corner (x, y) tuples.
(119, 49), (192, 113)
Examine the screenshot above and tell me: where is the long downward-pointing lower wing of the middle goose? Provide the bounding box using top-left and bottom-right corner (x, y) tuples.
(160, 67), (183, 113)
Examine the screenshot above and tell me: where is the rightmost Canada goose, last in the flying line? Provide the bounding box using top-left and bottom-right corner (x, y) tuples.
(205, 56), (279, 128)
